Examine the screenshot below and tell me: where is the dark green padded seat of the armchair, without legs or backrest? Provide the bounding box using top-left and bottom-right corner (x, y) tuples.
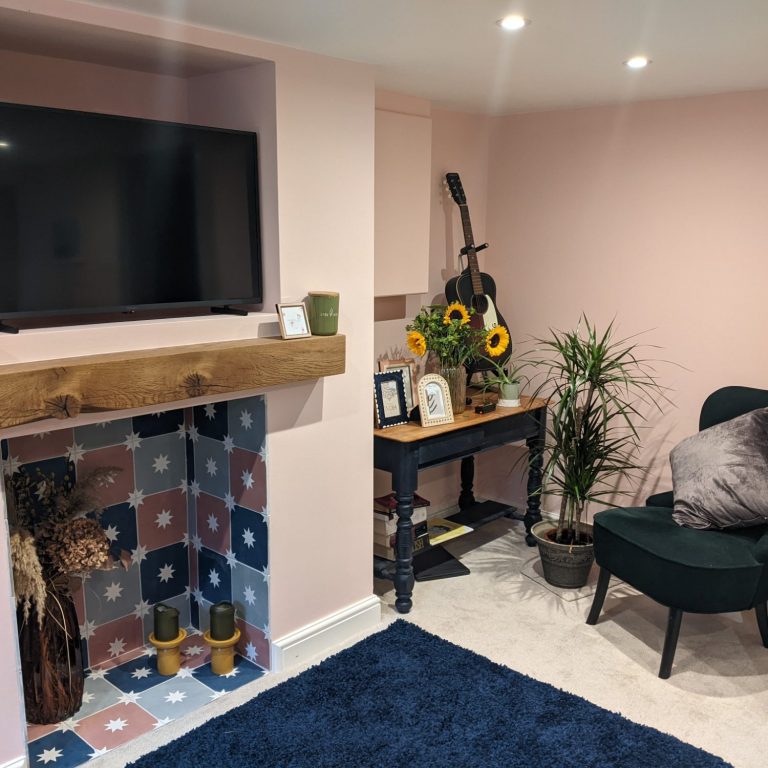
(594, 507), (768, 613)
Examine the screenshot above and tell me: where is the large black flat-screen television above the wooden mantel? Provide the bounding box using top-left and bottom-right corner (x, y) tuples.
(0, 104), (262, 319)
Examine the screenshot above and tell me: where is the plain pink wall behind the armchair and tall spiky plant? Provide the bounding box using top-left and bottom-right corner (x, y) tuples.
(487, 91), (768, 498)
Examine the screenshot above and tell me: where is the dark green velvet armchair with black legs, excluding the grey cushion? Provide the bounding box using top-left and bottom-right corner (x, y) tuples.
(587, 387), (768, 678)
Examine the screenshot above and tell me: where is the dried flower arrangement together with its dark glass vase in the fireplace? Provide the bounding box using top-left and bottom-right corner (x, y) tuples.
(6, 467), (120, 723)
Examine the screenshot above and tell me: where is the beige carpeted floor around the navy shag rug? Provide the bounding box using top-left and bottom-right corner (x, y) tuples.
(96, 520), (768, 768)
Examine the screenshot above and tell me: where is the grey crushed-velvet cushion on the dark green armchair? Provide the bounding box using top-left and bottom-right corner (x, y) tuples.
(669, 408), (768, 528)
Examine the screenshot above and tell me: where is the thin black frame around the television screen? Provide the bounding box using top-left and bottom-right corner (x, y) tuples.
(0, 101), (264, 320)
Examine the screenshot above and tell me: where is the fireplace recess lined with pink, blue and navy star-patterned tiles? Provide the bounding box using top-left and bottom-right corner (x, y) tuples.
(0, 396), (270, 766)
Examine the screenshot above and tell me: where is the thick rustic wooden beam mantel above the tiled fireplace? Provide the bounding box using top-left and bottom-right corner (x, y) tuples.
(0, 335), (346, 429)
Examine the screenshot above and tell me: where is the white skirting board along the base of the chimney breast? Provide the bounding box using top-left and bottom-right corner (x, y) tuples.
(272, 595), (381, 672)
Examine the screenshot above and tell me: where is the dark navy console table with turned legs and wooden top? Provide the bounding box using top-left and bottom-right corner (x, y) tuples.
(373, 397), (547, 613)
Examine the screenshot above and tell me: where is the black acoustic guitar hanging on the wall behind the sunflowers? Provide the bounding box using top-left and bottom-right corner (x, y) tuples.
(445, 173), (512, 372)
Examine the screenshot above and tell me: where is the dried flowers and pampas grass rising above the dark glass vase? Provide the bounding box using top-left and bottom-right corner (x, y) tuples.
(6, 467), (120, 625)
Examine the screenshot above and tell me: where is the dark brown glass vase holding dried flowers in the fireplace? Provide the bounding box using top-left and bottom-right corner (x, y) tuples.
(16, 587), (85, 725)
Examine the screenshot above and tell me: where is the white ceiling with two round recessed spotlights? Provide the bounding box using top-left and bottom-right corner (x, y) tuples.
(84, 0), (768, 115)
